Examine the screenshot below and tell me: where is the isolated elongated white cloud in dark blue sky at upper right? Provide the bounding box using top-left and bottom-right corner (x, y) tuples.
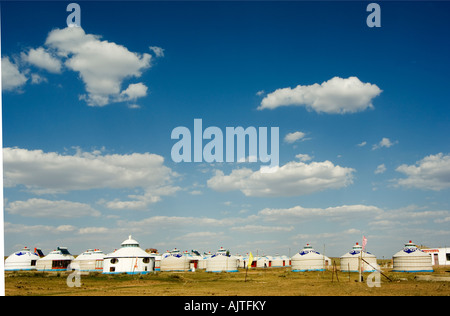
(258, 77), (382, 114)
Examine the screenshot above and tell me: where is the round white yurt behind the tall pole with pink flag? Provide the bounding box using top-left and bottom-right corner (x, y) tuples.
(341, 243), (378, 272)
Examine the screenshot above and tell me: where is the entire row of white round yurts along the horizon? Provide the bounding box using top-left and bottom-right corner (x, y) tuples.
(5, 236), (433, 274)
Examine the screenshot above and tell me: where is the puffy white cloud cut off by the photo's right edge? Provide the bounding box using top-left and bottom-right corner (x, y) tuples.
(395, 153), (450, 191)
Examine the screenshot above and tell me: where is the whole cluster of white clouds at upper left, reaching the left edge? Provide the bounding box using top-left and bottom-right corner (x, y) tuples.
(2, 27), (159, 108)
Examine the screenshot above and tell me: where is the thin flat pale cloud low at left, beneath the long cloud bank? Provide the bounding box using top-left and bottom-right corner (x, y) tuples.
(5, 198), (100, 218)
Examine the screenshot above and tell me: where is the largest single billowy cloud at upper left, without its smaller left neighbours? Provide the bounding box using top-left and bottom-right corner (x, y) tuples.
(45, 27), (151, 106)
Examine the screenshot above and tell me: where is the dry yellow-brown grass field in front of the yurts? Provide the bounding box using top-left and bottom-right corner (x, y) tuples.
(5, 268), (450, 297)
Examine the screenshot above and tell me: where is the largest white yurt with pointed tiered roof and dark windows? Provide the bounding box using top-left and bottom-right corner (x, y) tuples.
(103, 235), (155, 274)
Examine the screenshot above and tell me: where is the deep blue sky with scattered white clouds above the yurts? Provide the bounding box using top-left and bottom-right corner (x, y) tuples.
(1, 1), (450, 258)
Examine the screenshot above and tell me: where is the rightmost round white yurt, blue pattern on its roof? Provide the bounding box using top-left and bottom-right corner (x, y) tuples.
(392, 240), (433, 272)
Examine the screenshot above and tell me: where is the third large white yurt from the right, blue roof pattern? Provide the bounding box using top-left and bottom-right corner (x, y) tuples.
(291, 244), (331, 272)
